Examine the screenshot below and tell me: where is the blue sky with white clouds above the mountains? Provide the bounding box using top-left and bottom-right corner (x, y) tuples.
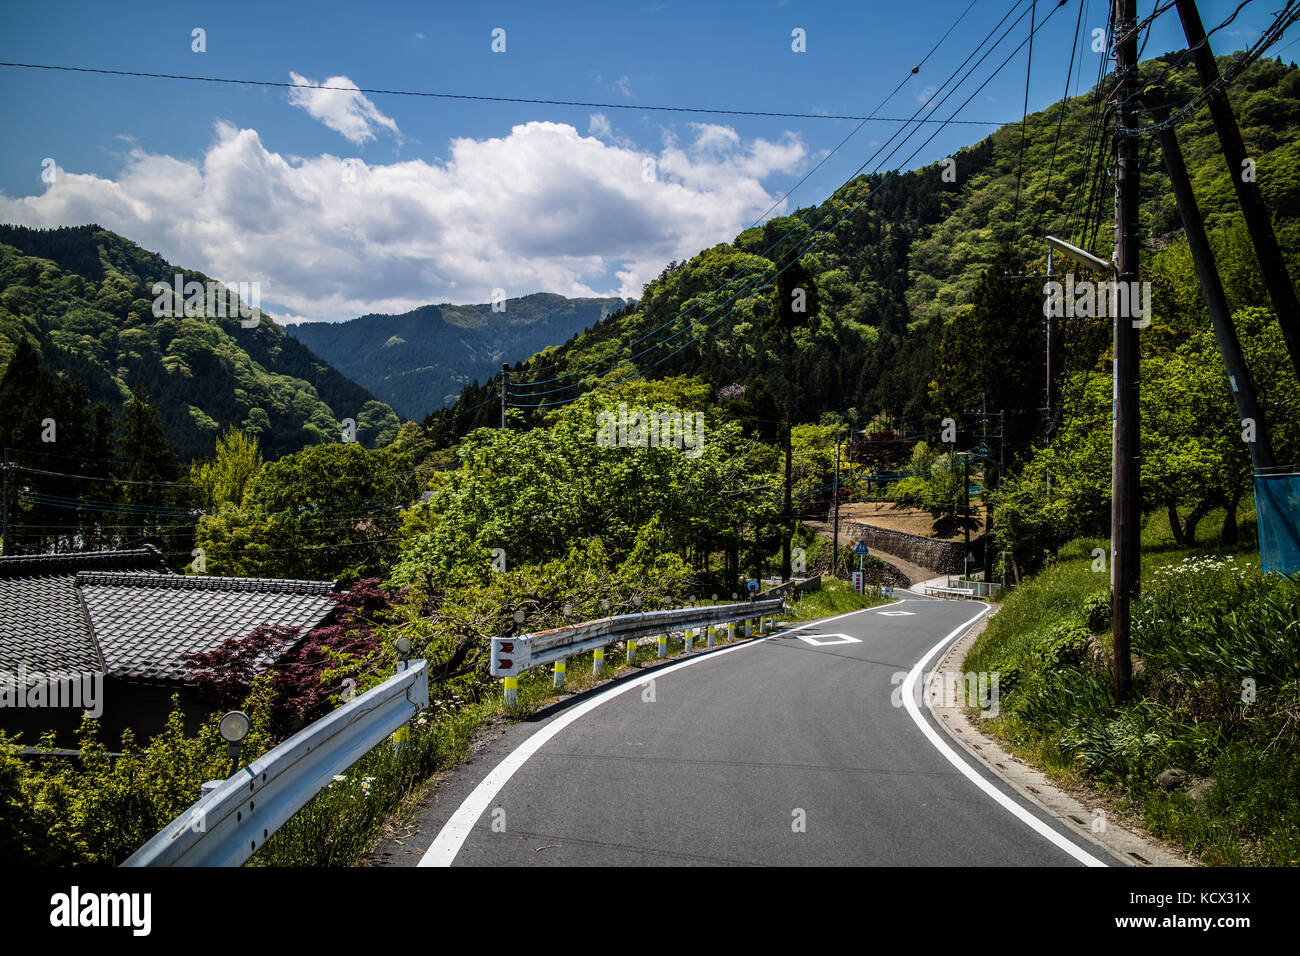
(0, 0), (1295, 321)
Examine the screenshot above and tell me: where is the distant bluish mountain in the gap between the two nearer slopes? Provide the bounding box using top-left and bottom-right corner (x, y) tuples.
(286, 293), (627, 419)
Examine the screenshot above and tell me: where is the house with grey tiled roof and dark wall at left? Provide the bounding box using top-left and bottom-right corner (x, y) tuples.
(0, 546), (335, 749)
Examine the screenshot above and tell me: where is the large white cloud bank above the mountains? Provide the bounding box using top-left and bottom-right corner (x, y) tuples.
(0, 117), (807, 320)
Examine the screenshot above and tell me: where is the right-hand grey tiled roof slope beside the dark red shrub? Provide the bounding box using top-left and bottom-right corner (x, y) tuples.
(77, 572), (334, 682)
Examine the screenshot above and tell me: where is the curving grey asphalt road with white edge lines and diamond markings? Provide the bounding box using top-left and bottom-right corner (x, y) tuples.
(374, 594), (1104, 866)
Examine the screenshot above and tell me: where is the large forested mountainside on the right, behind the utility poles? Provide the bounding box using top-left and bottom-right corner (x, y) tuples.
(426, 55), (1300, 460)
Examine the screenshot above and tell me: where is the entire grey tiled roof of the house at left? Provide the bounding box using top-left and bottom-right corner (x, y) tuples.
(0, 546), (334, 682)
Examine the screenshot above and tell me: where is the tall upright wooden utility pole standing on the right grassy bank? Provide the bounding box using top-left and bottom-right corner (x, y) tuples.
(1110, 0), (1141, 706)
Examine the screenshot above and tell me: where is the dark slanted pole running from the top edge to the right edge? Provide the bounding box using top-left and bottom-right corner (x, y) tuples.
(1177, 0), (1300, 376)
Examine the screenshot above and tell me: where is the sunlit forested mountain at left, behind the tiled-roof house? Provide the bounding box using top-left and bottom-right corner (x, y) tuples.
(0, 225), (399, 459)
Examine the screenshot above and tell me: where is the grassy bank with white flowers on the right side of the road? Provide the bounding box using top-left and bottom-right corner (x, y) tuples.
(965, 511), (1300, 866)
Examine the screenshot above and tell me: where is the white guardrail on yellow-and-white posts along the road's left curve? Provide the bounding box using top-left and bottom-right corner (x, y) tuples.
(489, 598), (785, 708)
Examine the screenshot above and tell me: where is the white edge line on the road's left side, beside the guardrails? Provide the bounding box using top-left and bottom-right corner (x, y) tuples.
(417, 607), (878, 866)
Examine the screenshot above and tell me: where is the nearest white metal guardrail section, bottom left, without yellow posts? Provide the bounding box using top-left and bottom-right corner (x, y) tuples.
(122, 661), (429, 866)
